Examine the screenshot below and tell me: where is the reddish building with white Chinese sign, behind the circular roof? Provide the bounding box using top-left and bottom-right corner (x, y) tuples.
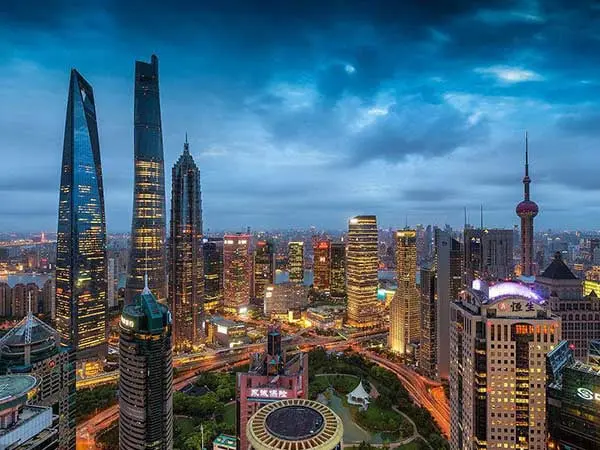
(236, 328), (308, 449)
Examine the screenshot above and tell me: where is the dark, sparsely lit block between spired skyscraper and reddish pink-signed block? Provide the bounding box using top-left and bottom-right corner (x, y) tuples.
(202, 237), (223, 313)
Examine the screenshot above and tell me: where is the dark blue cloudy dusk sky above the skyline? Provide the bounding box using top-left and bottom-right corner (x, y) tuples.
(0, 0), (600, 231)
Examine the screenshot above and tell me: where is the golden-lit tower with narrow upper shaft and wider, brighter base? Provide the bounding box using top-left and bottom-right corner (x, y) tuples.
(388, 229), (421, 354)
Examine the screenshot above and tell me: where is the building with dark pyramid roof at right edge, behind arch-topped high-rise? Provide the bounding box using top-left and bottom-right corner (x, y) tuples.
(535, 252), (600, 362)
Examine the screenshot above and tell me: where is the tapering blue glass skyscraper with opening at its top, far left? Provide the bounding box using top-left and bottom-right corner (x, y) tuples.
(56, 70), (107, 361)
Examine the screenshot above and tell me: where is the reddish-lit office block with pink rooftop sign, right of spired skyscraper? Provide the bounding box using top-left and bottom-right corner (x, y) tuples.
(223, 233), (252, 312)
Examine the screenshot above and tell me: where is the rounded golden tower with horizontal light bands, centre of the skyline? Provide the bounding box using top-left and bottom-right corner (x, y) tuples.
(346, 216), (379, 328)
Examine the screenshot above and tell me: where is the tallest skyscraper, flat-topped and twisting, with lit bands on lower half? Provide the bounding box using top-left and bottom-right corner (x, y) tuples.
(125, 55), (167, 304)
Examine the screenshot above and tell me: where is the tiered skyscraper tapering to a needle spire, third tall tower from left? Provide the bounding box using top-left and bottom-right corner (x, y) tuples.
(169, 136), (204, 350)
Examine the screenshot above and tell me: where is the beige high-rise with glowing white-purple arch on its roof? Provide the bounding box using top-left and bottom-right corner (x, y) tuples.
(450, 281), (561, 450)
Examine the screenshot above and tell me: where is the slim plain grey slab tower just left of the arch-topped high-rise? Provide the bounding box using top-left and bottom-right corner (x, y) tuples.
(434, 229), (463, 380)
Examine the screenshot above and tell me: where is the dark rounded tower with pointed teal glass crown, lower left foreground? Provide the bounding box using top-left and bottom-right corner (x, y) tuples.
(119, 286), (173, 450)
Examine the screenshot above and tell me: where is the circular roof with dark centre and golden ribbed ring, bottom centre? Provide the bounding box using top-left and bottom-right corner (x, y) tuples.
(246, 399), (343, 450)
